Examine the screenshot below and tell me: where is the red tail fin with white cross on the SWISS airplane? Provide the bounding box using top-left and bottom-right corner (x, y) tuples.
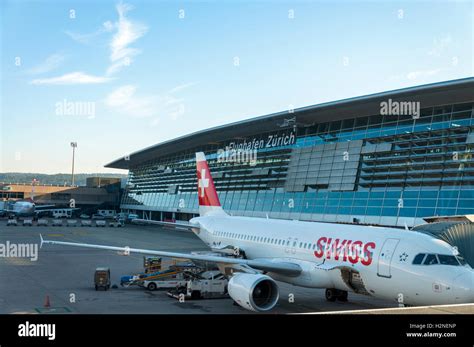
(196, 152), (226, 216)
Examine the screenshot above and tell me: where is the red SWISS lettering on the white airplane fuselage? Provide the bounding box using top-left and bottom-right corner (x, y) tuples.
(314, 237), (376, 266)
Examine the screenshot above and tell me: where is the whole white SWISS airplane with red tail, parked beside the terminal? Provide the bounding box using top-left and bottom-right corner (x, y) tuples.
(41, 152), (474, 311)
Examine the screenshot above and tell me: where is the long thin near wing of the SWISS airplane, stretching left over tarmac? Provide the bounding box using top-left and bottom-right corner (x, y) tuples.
(40, 234), (302, 276)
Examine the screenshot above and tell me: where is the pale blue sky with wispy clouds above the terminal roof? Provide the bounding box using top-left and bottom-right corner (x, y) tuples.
(0, 0), (474, 173)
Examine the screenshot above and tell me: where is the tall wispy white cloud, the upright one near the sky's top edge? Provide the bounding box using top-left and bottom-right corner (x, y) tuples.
(107, 3), (148, 75)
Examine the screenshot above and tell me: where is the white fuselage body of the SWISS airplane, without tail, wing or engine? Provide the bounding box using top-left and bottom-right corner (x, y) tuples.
(191, 216), (474, 305)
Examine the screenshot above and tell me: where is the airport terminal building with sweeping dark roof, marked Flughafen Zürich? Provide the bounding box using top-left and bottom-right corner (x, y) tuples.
(106, 78), (474, 226)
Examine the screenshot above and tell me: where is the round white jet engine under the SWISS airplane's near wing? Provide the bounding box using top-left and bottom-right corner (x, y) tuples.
(227, 273), (279, 311)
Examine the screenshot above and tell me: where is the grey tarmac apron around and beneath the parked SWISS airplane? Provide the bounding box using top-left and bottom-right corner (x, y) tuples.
(0, 220), (474, 314)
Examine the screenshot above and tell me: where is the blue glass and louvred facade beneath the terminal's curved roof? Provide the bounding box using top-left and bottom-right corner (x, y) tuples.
(122, 103), (474, 226)
